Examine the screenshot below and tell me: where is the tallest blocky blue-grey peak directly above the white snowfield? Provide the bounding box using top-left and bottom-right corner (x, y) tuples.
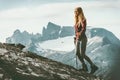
(41, 22), (74, 41)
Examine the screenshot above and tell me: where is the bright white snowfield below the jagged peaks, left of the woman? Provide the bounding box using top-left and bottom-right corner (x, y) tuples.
(39, 36), (74, 51)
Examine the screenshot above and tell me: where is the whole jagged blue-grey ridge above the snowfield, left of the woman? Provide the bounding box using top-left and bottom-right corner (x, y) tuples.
(6, 22), (74, 45)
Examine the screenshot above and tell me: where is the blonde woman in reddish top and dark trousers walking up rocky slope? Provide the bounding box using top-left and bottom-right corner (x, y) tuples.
(74, 7), (98, 74)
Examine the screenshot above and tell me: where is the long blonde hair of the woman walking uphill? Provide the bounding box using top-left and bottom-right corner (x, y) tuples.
(75, 7), (85, 24)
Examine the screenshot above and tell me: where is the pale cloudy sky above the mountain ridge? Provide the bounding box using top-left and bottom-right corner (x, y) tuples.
(0, 0), (120, 42)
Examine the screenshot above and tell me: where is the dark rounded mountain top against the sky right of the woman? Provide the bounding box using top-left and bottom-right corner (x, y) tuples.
(87, 28), (120, 46)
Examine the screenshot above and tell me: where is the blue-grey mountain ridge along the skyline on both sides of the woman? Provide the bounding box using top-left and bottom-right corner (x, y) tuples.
(6, 22), (120, 46)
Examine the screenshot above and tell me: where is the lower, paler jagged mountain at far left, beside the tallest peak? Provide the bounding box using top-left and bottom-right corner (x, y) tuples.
(6, 29), (41, 45)
